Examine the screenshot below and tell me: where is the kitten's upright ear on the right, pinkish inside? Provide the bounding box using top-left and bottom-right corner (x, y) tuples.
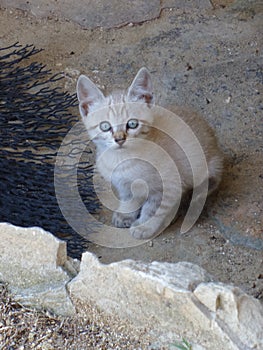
(128, 67), (153, 104)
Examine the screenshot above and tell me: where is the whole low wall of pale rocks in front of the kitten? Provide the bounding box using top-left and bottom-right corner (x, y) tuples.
(0, 223), (263, 350)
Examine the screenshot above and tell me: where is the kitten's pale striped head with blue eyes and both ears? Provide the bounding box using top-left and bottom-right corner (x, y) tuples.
(77, 68), (153, 148)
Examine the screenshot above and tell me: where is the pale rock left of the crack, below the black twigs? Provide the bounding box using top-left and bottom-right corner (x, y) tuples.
(0, 223), (77, 315)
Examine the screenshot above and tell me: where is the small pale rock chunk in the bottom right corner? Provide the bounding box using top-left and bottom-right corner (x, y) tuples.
(194, 283), (263, 349)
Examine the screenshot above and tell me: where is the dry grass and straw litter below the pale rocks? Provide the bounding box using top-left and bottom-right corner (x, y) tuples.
(0, 284), (152, 350)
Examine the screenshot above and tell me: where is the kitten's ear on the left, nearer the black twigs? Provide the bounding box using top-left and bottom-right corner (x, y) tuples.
(77, 75), (105, 118)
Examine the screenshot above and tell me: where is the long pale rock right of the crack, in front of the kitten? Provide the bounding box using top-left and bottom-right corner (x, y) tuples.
(68, 253), (263, 350)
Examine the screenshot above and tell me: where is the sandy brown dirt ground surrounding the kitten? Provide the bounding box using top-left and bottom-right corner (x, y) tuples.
(0, 1), (263, 306)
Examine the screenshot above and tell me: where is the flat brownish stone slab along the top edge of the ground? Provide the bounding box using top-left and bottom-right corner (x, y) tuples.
(0, 0), (212, 29)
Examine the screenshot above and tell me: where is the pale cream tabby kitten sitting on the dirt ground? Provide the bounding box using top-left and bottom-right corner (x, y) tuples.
(77, 68), (223, 239)
